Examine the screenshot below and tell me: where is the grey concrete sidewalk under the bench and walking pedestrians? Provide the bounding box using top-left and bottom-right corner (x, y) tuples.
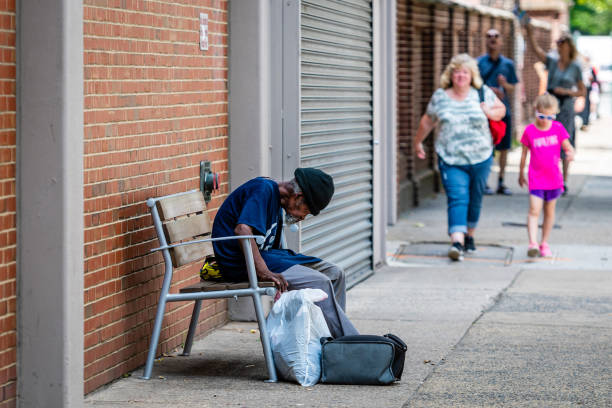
(86, 115), (612, 407)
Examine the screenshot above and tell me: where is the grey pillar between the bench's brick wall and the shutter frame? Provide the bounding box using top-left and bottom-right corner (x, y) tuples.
(229, 0), (278, 190)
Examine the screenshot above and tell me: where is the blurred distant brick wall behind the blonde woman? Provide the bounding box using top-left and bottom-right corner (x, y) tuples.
(397, 0), (537, 211)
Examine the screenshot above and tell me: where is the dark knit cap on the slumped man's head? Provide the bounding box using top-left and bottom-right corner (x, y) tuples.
(293, 167), (334, 215)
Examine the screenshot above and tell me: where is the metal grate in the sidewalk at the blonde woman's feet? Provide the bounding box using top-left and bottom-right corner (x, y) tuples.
(392, 242), (514, 266)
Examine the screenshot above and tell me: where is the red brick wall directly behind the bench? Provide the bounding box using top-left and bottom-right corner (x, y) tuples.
(83, 0), (228, 393)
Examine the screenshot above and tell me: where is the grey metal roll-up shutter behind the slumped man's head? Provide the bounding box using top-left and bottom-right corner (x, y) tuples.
(300, 0), (373, 286)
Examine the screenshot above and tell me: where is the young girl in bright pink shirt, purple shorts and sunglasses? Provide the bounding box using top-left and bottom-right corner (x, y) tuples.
(519, 93), (574, 257)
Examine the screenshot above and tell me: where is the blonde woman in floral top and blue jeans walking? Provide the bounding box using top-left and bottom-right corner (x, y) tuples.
(414, 54), (506, 261)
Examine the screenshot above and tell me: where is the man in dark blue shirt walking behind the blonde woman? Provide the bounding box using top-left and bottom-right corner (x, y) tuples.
(478, 28), (518, 195)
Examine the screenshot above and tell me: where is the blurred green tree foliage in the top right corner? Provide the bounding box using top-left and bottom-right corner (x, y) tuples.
(570, 0), (612, 35)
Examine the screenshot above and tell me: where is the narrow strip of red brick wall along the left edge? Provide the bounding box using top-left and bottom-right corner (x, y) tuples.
(0, 0), (17, 407)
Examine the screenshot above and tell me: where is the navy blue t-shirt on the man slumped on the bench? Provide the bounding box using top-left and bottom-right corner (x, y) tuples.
(212, 177), (320, 280)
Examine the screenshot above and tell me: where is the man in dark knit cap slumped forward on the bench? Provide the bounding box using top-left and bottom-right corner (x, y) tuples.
(212, 168), (358, 337)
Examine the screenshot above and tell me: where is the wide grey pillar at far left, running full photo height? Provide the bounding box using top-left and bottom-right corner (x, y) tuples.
(17, 0), (83, 407)
